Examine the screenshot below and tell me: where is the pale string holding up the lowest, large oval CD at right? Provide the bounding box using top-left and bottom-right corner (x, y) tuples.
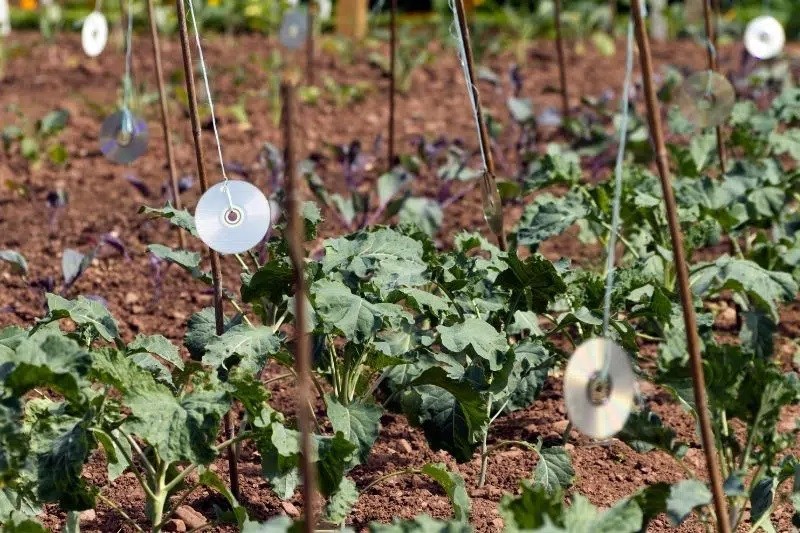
(600, 20), (633, 378)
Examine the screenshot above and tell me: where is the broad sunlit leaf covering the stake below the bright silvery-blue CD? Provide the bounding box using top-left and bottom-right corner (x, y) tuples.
(203, 324), (281, 373)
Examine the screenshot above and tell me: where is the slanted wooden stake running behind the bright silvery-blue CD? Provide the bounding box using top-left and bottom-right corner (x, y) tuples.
(175, 0), (239, 498)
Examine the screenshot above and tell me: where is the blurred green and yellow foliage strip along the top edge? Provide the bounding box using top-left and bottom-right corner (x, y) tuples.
(6, 0), (800, 39)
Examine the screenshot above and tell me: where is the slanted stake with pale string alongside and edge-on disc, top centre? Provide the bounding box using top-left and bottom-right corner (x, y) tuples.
(454, 0), (508, 251)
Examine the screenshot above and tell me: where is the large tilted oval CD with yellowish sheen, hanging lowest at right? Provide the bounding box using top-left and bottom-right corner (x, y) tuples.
(564, 337), (636, 439)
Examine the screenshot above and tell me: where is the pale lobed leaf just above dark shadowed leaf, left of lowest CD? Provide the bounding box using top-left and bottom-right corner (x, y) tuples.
(436, 317), (508, 371)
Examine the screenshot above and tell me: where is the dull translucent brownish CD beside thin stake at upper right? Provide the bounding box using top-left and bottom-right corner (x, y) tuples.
(677, 70), (736, 128)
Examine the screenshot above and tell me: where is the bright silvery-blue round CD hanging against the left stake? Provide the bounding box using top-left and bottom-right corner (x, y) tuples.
(194, 180), (272, 255)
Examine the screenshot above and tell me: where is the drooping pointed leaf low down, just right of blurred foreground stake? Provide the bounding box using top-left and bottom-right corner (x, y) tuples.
(325, 394), (383, 463)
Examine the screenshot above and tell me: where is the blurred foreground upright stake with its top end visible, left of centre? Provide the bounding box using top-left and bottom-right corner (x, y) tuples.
(281, 81), (316, 533)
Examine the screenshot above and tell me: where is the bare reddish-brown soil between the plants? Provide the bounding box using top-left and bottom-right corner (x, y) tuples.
(0, 29), (800, 531)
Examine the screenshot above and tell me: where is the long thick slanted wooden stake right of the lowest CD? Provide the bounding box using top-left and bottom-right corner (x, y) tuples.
(631, 0), (731, 533)
